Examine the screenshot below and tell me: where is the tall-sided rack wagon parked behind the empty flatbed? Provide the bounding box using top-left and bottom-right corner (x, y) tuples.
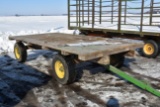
(68, 0), (160, 58)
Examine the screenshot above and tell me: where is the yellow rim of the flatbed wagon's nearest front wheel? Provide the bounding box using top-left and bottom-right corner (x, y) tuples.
(55, 61), (65, 79)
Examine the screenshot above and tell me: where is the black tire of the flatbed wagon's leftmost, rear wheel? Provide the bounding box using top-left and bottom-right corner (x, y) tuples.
(14, 42), (27, 63)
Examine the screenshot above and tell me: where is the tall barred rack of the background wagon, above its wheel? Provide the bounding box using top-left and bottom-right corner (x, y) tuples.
(68, 0), (160, 36)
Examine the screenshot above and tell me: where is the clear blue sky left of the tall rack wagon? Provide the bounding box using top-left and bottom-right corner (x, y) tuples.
(0, 0), (67, 15)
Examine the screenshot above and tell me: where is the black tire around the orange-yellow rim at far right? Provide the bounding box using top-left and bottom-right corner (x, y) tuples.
(142, 40), (160, 58)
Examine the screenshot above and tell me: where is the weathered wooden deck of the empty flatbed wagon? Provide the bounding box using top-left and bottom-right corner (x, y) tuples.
(9, 33), (143, 61)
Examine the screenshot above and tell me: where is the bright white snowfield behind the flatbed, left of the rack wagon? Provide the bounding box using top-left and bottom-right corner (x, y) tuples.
(0, 16), (73, 54)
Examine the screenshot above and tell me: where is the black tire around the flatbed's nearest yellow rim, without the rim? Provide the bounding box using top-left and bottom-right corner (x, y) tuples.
(50, 55), (76, 85)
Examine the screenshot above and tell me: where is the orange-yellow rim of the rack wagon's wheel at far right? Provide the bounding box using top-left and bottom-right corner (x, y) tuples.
(143, 43), (155, 55)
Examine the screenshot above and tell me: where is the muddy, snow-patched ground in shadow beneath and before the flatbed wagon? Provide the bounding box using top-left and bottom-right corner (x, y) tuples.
(0, 51), (160, 107)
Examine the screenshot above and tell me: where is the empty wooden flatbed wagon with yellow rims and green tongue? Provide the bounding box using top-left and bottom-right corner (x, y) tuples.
(9, 33), (160, 97)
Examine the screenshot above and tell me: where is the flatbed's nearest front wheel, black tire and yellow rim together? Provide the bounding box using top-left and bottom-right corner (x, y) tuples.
(50, 55), (76, 84)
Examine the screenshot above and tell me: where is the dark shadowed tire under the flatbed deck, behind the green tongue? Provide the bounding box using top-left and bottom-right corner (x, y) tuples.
(110, 54), (125, 68)
